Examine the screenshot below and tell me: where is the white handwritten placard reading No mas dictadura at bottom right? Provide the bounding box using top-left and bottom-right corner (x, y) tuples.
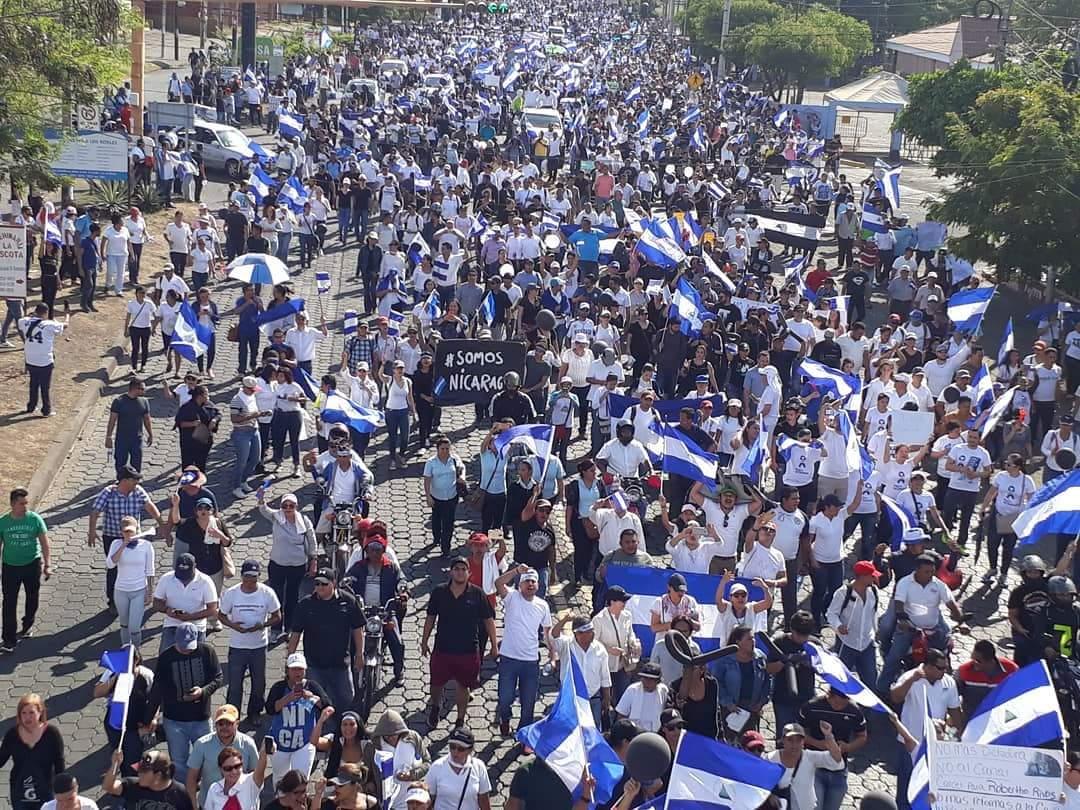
(930, 742), (1064, 810)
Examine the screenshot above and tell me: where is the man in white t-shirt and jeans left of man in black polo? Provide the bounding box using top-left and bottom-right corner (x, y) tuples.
(218, 559), (281, 720)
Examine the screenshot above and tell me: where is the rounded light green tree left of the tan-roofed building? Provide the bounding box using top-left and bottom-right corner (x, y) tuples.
(746, 6), (874, 102)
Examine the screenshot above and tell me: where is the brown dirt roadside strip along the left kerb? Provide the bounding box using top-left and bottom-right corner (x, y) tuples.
(0, 202), (203, 491)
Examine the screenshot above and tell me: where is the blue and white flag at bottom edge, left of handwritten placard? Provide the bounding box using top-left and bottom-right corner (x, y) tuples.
(665, 731), (784, 810)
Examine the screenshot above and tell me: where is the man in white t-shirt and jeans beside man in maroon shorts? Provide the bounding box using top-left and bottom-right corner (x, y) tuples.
(495, 565), (558, 737)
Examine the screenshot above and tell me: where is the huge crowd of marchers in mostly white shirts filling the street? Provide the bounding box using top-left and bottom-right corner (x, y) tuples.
(0, 2), (1080, 810)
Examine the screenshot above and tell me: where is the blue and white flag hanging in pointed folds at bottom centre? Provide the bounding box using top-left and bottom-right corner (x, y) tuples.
(516, 656), (623, 802)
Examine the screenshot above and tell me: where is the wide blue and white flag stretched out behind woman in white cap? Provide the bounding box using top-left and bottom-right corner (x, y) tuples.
(604, 565), (765, 658)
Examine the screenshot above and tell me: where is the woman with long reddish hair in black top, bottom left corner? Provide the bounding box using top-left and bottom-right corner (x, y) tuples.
(0, 692), (64, 810)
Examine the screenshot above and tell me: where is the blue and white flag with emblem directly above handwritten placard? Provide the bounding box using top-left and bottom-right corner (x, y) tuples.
(960, 661), (1065, 748)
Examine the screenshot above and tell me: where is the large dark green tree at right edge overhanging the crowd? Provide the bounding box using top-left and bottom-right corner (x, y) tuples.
(928, 81), (1080, 289)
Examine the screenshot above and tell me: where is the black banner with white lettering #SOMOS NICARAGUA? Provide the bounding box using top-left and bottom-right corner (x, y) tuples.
(434, 340), (525, 405)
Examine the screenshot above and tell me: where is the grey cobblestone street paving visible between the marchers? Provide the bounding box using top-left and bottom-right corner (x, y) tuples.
(0, 229), (1045, 807)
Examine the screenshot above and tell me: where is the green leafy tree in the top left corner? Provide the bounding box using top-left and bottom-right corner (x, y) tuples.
(0, 0), (136, 188)
